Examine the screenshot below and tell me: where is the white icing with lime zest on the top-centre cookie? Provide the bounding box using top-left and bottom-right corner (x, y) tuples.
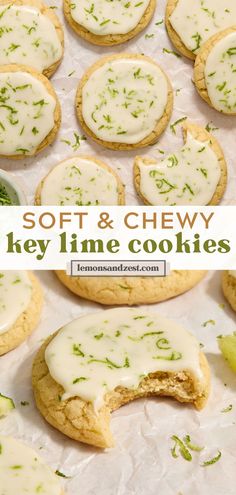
(71, 0), (150, 36)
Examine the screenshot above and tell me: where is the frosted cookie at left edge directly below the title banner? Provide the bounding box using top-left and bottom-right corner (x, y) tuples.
(0, 270), (43, 356)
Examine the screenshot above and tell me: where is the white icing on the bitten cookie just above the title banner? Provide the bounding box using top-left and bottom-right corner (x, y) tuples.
(137, 132), (221, 206)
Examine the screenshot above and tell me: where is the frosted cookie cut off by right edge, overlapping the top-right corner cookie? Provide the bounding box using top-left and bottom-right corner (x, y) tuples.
(194, 26), (236, 115)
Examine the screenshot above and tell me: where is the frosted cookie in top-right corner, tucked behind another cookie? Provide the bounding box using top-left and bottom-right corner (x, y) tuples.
(166, 0), (236, 60)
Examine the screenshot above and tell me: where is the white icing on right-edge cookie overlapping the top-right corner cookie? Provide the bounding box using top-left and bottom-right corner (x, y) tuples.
(205, 31), (236, 114)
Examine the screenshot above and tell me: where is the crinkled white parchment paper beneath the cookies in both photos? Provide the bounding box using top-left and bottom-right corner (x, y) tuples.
(0, 0), (236, 495)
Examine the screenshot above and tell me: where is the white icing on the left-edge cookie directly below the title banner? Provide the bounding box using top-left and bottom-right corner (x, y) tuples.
(0, 270), (32, 334)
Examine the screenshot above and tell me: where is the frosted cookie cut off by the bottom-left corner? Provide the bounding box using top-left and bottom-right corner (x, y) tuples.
(0, 435), (63, 495)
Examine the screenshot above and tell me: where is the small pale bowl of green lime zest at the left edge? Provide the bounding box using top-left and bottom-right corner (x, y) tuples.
(0, 169), (27, 206)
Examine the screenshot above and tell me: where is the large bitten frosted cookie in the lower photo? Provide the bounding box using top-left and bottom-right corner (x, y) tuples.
(32, 308), (210, 448)
